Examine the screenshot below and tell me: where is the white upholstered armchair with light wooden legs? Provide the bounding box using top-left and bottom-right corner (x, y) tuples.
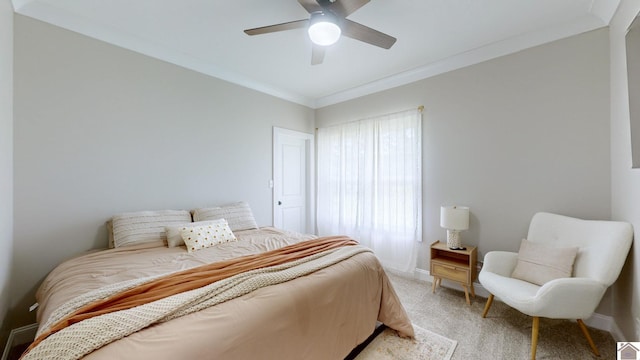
(478, 213), (633, 359)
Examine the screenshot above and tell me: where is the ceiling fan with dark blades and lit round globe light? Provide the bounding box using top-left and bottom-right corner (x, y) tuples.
(244, 0), (396, 65)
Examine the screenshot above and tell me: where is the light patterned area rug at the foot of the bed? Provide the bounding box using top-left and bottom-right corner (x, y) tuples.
(355, 325), (458, 360)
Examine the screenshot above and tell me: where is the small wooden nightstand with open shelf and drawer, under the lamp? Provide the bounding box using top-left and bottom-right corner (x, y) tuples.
(429, 240), (478, 305)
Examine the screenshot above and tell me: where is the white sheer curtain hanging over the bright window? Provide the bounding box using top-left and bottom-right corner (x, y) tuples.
(316, 110), (422, 272)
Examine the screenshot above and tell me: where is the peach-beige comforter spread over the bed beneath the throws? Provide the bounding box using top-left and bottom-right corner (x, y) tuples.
(37, 228), (413, 359)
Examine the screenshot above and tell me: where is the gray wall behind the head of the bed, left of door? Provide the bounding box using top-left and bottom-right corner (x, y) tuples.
(12, 15), (314, 325)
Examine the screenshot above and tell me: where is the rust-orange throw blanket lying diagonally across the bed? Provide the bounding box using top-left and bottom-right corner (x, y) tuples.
(25, 236), (358, 354)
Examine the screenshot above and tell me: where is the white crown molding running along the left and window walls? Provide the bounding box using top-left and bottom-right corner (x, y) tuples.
(12, 0), (608, 109)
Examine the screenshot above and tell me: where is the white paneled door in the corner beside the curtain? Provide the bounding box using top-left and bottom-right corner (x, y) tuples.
(273, 127), (315, 233)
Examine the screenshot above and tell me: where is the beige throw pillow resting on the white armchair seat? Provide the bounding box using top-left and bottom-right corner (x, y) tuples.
(511, 239), (578, 286)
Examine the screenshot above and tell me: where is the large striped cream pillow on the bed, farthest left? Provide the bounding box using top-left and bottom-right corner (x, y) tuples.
(111, 210), (191, 247)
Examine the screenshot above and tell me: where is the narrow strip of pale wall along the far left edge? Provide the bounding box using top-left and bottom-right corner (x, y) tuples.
(0, 0), (13, 352)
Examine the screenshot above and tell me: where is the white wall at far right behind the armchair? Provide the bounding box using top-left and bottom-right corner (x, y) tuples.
(609, 0), (640, 341)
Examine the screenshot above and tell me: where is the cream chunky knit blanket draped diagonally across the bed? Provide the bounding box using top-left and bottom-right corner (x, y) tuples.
(22, 245), (370, 360)
